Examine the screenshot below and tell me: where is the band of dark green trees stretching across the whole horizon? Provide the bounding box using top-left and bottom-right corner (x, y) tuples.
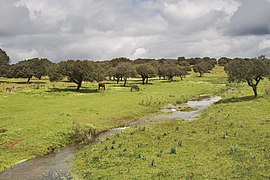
(0, 49), (270, 96)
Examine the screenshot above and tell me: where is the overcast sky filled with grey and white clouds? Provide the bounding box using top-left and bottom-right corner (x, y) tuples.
(0, 0), (270, 63)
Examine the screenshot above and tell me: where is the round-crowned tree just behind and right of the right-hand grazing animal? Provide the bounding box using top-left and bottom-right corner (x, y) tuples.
(136, 64), (156, 84)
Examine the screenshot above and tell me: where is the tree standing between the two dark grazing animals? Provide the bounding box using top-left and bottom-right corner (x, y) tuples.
(114, 63), (136, 87)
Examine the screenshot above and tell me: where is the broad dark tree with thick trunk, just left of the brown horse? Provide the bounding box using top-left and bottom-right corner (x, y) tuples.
(57, 60), (101, 91)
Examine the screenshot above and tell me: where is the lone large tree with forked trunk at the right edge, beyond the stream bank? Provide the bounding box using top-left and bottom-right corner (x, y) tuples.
(225, 58), (270, 97)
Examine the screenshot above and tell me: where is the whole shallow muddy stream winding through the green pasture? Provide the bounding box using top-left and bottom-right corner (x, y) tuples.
(0, 96), (221, 180)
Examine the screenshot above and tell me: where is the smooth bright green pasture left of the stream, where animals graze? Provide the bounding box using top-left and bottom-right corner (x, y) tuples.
(0, 68), (226, 171)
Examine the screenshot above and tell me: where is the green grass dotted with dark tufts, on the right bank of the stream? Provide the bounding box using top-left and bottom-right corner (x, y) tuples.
(74, 69), (270, 179)
